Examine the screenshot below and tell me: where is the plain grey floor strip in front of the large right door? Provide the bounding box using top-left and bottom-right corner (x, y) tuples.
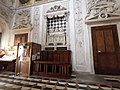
(76, 73), (120, 86)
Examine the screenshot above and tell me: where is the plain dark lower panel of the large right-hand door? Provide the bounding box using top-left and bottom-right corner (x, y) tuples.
(96, 53), (119, 75)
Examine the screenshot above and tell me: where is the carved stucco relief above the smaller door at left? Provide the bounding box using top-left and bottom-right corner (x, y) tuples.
(13, 9), (32, 29)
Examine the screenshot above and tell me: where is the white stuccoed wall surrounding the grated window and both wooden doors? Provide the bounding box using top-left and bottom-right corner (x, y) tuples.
(2, 0), (120, 74)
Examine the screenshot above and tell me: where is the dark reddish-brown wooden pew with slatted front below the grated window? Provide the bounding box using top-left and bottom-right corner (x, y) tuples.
(33, 51), (71, 78)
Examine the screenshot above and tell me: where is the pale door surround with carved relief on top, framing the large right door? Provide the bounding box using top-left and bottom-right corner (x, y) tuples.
(85, 0), (120, 73)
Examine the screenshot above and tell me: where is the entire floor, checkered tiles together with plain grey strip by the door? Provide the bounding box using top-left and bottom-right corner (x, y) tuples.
(0, 72), (120, 90)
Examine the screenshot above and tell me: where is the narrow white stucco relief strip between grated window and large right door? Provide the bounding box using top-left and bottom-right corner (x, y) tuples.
(74, 0), (85, 67)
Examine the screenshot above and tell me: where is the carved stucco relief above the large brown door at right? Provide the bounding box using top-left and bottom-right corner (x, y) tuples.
(86, 0), (120, 20)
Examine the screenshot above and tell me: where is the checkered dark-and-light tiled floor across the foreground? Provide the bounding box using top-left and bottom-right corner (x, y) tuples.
(0, 74), (120, 90)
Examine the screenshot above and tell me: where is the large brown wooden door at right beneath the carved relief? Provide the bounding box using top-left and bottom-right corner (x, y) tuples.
(92, 25), (120, 75)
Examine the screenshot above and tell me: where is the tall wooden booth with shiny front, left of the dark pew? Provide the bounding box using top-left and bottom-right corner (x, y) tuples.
(15, 42), (41, 77)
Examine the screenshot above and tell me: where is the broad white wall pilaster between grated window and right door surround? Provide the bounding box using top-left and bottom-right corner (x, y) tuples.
(73, 0), (93, 73)
